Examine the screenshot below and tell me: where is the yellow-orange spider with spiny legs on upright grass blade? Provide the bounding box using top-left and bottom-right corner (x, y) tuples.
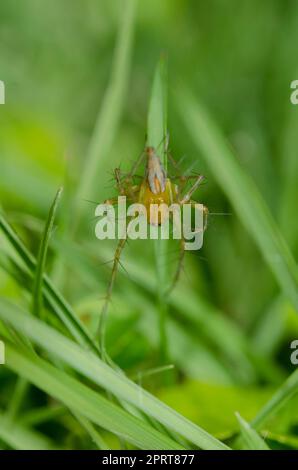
(98, 146), (208, 355)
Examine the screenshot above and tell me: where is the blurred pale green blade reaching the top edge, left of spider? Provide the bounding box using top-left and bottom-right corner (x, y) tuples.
(77, 0), (137, 219)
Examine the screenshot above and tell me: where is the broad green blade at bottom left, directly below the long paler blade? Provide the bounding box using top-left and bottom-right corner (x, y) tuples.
(6, 344), (181, 449)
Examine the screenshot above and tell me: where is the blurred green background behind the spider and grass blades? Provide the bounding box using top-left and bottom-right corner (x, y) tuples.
(0, 0), (298, 448)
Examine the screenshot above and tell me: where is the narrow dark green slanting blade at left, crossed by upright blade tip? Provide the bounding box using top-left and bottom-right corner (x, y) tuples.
(0, 213), (98, 352)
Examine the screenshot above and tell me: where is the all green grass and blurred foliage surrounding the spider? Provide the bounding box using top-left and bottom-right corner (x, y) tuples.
(0, 0), (298, 449)
